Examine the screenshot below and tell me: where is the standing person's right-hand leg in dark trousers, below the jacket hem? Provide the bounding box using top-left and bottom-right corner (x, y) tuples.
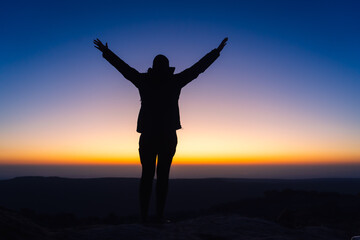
(156, 131), (177, 220)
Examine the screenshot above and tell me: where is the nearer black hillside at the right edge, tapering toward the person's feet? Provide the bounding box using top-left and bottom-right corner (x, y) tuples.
(208, 189), (360, 234)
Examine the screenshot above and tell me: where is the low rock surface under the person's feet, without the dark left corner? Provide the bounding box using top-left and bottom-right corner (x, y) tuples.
(61, 215), (344, 240)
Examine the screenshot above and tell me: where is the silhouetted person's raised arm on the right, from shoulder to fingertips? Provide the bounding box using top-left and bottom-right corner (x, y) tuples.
(176, 38), (228, 87)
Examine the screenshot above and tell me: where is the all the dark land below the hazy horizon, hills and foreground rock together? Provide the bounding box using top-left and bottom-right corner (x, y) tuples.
(0, 177), (360, 240)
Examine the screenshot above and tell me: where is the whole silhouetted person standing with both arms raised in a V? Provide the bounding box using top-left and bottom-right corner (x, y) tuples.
(94, 38), (228, 222)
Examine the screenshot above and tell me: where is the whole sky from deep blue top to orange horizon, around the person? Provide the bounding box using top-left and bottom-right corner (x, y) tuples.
(0, 0), (360, 176)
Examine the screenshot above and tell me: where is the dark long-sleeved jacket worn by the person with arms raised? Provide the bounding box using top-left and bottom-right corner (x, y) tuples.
(103, 49), (220, 133)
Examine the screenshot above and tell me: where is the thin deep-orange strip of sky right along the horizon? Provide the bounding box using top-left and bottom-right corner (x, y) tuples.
(0, 154), (360, 165)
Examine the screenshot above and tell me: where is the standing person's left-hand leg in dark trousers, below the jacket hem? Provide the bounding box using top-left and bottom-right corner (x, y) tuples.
(139, 133), (156, 222)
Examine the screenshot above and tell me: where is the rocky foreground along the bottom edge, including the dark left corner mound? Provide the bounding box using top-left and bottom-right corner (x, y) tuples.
(0, 209), (350, 240)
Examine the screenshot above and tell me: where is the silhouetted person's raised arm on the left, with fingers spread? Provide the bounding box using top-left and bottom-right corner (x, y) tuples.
(94, 38), (140, 87)
